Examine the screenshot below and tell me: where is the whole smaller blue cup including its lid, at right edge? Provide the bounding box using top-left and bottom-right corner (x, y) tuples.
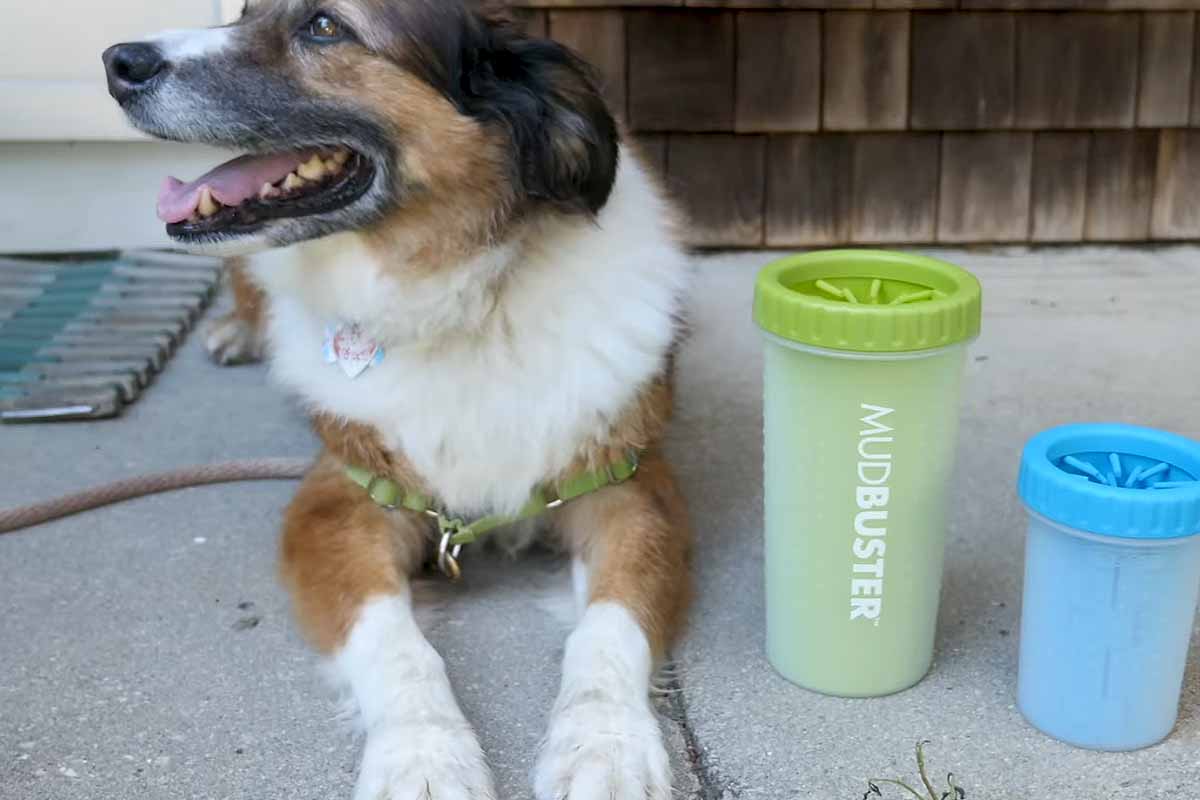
(1018, 425), (1200, 751)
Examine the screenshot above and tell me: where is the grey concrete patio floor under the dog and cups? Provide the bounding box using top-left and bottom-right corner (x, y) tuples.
(0, 247), (1200, 800)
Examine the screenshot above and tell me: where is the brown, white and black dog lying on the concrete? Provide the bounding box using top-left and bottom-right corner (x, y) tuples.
(104, 0), (689, 800)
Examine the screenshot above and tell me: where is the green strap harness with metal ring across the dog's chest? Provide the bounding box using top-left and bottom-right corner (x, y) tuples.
(346, 450), (640, 579)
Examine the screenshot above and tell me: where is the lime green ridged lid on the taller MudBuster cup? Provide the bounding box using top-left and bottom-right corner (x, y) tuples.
(754, 249), (983, 353)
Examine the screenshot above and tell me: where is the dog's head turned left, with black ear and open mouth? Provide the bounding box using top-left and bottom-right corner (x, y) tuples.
(104, 0), (618, 248)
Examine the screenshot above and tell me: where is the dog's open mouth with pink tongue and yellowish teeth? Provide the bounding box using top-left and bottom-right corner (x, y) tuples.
(158, 148), (374, 239)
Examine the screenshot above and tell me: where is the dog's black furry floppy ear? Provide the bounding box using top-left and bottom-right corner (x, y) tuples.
(460, 17), (619, 215)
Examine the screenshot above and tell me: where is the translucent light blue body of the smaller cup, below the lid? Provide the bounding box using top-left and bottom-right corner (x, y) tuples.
(1018, 513), (1200, 751)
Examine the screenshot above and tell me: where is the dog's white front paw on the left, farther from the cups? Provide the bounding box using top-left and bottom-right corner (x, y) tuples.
(354, 720), (496, 800)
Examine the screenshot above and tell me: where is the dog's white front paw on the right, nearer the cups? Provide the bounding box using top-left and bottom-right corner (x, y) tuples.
(534, 694), (671, 800)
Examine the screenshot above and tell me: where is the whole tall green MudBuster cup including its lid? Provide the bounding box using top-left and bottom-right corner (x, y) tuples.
(755, 251), (982, 697)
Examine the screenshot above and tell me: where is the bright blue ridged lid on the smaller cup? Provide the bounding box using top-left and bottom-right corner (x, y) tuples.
(1019, 425), (1200, 539)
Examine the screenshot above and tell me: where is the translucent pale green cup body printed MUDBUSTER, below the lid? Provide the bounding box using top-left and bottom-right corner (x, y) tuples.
(764, 333), (966, 697)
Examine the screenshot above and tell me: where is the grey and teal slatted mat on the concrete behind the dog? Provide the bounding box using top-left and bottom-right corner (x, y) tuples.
(0, 251), (221, 423)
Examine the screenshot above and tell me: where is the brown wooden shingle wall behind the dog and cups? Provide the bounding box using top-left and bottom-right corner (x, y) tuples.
(517, 0), (1200, 247)
